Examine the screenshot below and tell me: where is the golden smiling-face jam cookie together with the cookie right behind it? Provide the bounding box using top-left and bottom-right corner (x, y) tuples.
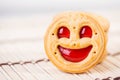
(44, 12), (109, 73)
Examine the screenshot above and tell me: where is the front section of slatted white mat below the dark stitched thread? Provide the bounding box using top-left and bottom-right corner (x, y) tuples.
(0, 55), (120, 80)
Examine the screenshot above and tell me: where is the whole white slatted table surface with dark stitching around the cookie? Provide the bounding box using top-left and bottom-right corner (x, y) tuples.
(0, 11), (120, 80)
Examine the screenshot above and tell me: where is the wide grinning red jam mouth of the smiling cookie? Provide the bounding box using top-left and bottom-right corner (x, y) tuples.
(58, 45), (92, 62)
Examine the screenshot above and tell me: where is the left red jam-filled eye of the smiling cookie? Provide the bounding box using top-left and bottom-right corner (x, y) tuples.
(57, 26), (70, 38)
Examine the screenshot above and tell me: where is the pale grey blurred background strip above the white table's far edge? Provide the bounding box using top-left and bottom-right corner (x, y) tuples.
(0, 0), (120, 15)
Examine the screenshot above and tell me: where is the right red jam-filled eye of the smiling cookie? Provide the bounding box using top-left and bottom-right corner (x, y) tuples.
(79, 26), (92, 38)
